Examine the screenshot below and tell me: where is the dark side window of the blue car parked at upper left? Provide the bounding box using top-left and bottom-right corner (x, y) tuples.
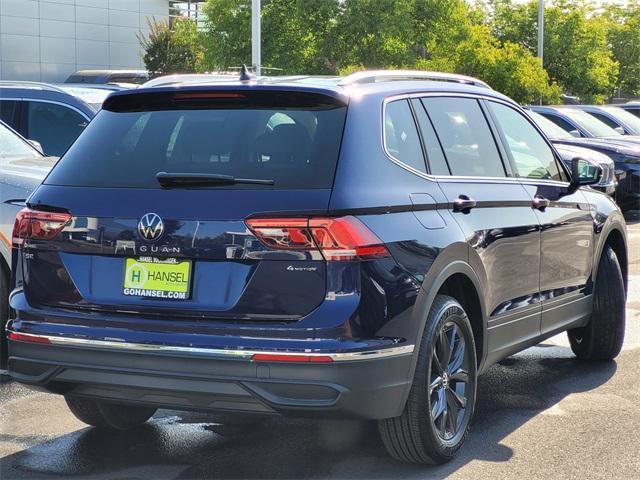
(27, 101), (88, 157)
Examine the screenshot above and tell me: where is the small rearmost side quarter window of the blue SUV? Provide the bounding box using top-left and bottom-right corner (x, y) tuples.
(384, 100), (427, 173)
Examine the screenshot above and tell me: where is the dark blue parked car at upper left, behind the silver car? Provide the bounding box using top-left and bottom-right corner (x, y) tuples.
(0, 81), (104, 156)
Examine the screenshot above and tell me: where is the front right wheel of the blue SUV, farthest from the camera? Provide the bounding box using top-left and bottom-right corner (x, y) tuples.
(567, 247), (625, 360)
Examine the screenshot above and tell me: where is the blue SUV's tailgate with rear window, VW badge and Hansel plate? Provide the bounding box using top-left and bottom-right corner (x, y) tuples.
(24, 92), (346, 321)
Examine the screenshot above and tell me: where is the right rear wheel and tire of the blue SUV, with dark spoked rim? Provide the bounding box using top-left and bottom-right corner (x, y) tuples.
(378, 295), (477, 464)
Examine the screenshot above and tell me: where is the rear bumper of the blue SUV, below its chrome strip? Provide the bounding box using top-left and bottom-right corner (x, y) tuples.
(8, 337), (413, 419)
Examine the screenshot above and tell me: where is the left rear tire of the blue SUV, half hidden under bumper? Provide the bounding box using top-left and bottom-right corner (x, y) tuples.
(64, 396), (156, 430)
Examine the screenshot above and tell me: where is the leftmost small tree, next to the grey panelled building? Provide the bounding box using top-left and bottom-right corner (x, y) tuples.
(138, 19), (203, 76)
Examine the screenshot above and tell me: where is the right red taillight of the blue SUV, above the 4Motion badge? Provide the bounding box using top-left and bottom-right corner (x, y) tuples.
(246, 216), (389, 261)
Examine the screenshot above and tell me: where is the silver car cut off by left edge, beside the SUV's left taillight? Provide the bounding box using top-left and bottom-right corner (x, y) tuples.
(0, 121), (57, 370)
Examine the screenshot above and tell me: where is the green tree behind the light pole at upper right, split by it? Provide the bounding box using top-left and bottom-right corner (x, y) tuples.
(490, 0), (618, 102)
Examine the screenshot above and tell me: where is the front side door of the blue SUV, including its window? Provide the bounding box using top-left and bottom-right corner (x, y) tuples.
(487, 102), (594, 333)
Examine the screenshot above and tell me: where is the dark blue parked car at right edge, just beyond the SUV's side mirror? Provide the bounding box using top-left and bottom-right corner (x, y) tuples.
(528, 110), (640, 210)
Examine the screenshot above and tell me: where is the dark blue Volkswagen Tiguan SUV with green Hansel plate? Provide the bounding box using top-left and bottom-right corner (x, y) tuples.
(7, 72), (627, 463)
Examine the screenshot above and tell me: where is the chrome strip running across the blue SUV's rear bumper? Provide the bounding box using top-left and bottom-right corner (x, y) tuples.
(7, 330), (414, 362)
